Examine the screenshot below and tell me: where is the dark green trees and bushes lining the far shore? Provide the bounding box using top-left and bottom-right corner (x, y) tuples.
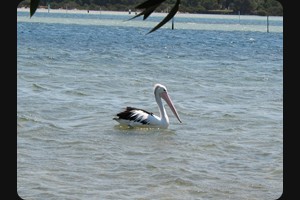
(18, 0), (283, 16)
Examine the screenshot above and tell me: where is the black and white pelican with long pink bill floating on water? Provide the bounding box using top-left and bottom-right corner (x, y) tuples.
(113, 84), (181, 128)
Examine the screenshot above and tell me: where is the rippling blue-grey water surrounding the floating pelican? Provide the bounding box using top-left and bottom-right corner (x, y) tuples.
(17, 11), (283, 200)
